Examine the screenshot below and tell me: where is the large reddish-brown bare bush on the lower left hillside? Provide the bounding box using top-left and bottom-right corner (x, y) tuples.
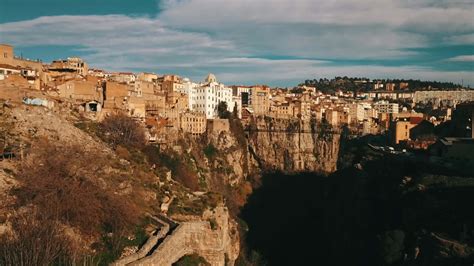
(15, 142), (137, 234)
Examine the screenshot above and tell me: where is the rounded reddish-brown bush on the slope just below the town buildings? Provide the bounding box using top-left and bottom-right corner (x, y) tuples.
(99, 114), (145, 148)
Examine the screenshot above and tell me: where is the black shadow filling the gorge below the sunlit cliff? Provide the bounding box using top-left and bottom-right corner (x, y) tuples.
(241, 158), (474, 266)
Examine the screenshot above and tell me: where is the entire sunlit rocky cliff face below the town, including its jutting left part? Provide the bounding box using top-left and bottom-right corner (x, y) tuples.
(183, 118), (340, 192)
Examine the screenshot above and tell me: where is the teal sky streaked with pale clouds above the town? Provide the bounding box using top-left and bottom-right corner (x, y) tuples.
(0, 0), (474, 87)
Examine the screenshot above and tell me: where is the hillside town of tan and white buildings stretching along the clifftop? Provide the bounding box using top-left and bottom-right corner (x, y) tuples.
(0, 44), (474, 168)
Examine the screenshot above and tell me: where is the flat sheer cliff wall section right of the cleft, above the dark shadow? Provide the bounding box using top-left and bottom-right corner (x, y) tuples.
(248, 118), (340, 173)
